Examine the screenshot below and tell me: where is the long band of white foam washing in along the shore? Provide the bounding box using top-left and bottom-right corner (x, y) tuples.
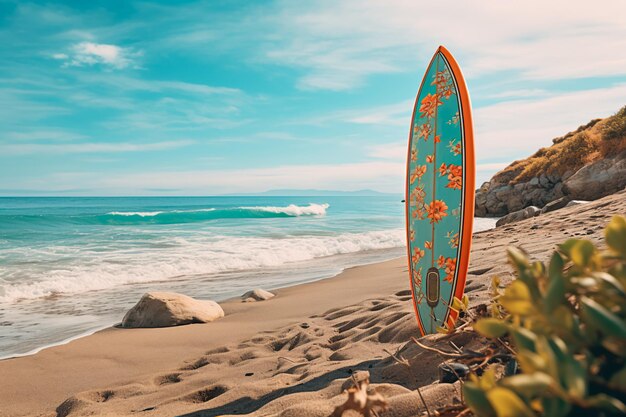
(0, 229), (405, 302)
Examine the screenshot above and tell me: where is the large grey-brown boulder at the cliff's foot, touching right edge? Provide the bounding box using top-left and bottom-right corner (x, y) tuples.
(565, 151), (626, 200)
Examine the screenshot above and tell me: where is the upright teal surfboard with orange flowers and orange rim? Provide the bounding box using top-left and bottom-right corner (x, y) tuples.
(405, 46), (476, 335)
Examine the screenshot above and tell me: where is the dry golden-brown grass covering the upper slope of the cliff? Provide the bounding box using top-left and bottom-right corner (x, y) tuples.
(494, 106), (626, 184)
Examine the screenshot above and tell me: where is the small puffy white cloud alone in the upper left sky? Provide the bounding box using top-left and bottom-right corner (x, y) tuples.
(52, 42), (141, 69)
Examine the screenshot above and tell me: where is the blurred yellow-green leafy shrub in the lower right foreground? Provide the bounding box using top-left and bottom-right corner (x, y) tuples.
(463, 216), (626, 417)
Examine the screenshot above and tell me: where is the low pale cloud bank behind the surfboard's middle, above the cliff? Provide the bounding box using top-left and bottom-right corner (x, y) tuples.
(344, 84), (626, 170)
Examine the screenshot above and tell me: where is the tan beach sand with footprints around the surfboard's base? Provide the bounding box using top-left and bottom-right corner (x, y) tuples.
(0, 192), (626, 417)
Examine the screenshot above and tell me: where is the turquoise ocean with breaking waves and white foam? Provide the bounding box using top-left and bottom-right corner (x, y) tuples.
(0, 195), (495, 358)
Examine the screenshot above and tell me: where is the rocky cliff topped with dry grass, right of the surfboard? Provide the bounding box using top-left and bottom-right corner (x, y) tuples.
(476, 106), (626, 217)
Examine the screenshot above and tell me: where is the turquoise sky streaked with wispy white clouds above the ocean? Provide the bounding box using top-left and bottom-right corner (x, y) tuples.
(0, 0), (626, 195)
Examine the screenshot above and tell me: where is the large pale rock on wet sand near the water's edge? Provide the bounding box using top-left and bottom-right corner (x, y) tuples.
(122, 292), (224, 327)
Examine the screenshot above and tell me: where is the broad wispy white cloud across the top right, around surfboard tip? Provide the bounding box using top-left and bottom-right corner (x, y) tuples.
(255, 0), (626, 90)
